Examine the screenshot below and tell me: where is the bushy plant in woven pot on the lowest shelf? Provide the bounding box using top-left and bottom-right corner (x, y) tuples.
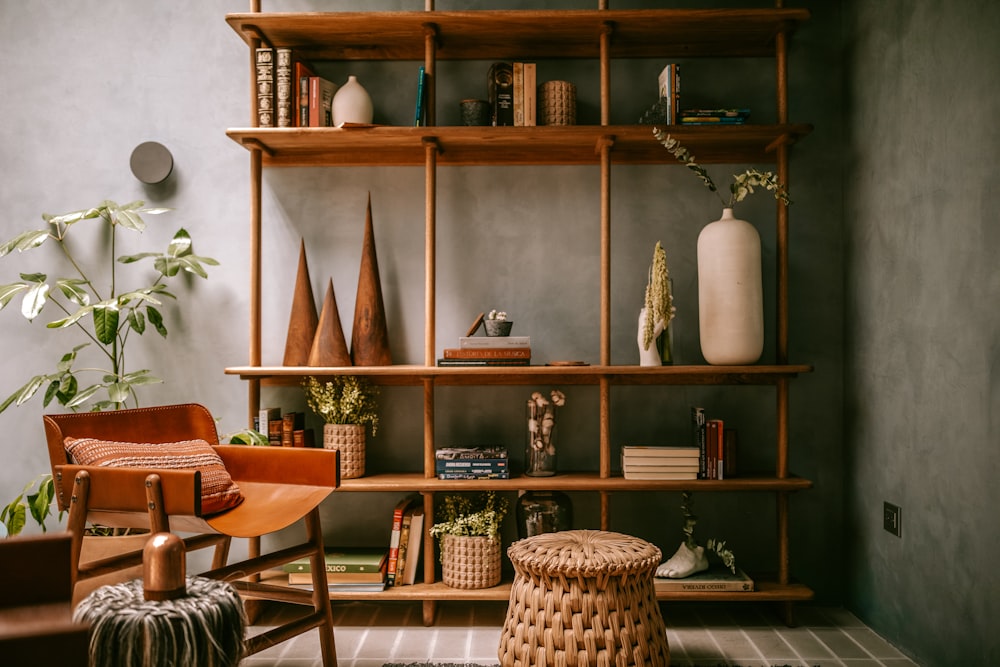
(431, 491), (508, 589)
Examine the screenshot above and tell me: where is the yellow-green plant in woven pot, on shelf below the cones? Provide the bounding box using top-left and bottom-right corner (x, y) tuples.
(302, 375), (379, 479)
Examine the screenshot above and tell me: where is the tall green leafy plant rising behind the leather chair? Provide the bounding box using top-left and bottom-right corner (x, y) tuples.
(0, 201), (218, 412)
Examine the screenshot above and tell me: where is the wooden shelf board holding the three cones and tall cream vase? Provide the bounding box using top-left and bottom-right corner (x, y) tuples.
(226, 364), (812, 387)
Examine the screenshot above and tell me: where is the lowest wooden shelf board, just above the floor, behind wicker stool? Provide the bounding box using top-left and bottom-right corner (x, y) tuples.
(254, 572), (813, 602)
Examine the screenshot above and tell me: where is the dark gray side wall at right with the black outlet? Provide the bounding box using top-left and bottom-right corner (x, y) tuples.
(844, 1), (1000, 666)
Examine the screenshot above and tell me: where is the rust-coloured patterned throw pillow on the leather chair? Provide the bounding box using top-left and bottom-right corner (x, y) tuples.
(64, 438), (243, 515)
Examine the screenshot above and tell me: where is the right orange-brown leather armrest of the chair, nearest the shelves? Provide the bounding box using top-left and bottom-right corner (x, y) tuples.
(215, 445), (340, 489)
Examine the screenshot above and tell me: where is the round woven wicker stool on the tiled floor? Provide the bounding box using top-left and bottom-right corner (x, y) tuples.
(497, 530), (670, 667)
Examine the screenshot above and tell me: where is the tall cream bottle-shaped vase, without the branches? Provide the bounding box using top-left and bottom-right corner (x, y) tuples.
(698, 208), (764, 366)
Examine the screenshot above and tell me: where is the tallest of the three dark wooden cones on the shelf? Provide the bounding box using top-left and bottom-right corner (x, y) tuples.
(351, 193), (392, 366)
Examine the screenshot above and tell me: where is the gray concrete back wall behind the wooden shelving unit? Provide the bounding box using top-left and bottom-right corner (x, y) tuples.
(0, 0), (848, 632)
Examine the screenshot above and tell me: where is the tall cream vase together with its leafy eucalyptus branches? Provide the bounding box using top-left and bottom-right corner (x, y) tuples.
(653, 129), (791, 365)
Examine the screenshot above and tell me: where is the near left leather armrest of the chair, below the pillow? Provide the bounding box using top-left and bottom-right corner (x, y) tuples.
(55, 465), (201, 516)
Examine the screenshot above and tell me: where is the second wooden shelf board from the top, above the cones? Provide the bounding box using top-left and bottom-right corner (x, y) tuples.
(226, 124), (812, 167)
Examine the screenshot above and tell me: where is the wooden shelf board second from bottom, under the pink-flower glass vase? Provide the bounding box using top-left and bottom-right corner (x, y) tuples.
(340, 472), (812, 493)
